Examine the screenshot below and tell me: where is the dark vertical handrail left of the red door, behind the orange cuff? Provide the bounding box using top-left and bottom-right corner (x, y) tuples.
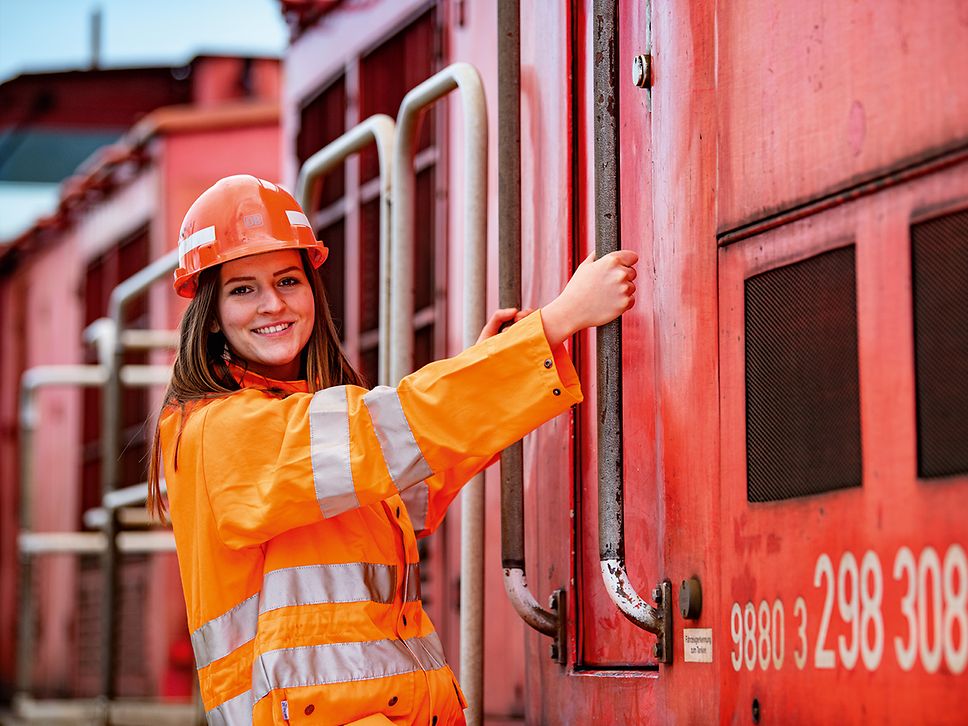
(497, 0), (565, 662)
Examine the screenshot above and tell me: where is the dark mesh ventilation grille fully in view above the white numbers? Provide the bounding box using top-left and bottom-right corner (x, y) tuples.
(745, 247), (861, 502)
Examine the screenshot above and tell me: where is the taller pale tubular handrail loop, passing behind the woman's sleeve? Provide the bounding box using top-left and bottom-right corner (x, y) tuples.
(390, 63), (487, 725)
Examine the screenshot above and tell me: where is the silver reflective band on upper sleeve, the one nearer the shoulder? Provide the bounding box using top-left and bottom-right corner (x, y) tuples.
(309, 386), (360, 517)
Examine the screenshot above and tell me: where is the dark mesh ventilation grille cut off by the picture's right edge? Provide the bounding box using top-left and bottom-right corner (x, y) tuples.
(911, 211), (968, 479)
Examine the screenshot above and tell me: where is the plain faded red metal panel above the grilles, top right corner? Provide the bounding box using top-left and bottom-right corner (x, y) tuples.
(716, 0), (968, 229)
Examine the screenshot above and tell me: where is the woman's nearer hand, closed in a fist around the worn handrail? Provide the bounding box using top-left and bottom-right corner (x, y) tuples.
(541, 250), (639, 347)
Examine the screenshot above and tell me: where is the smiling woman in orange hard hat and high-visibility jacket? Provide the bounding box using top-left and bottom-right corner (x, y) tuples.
(149, 176), (637, 725)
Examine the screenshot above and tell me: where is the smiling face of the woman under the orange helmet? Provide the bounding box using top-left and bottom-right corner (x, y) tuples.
(218, 250), (315, 381)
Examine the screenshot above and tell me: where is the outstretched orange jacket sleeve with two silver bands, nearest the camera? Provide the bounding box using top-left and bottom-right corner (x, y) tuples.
(199, 312), (581, 547)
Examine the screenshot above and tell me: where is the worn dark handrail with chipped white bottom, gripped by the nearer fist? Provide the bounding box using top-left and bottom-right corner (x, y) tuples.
(592, 0), (672, 663)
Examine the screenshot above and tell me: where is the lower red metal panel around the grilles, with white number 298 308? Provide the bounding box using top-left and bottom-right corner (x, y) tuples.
(716, 163), (968, 723)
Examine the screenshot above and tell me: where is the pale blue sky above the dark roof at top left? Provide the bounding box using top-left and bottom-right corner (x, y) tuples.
(0, 0), (288, 82)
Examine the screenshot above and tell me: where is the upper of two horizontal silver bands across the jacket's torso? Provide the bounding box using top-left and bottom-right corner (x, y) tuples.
(259, 562), (397, 613)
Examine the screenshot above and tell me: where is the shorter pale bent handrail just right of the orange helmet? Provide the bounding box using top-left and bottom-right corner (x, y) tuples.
(296, 113), (395, 386)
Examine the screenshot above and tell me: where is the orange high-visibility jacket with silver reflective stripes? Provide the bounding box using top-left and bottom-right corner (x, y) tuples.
(161, 312), (581, 726)
